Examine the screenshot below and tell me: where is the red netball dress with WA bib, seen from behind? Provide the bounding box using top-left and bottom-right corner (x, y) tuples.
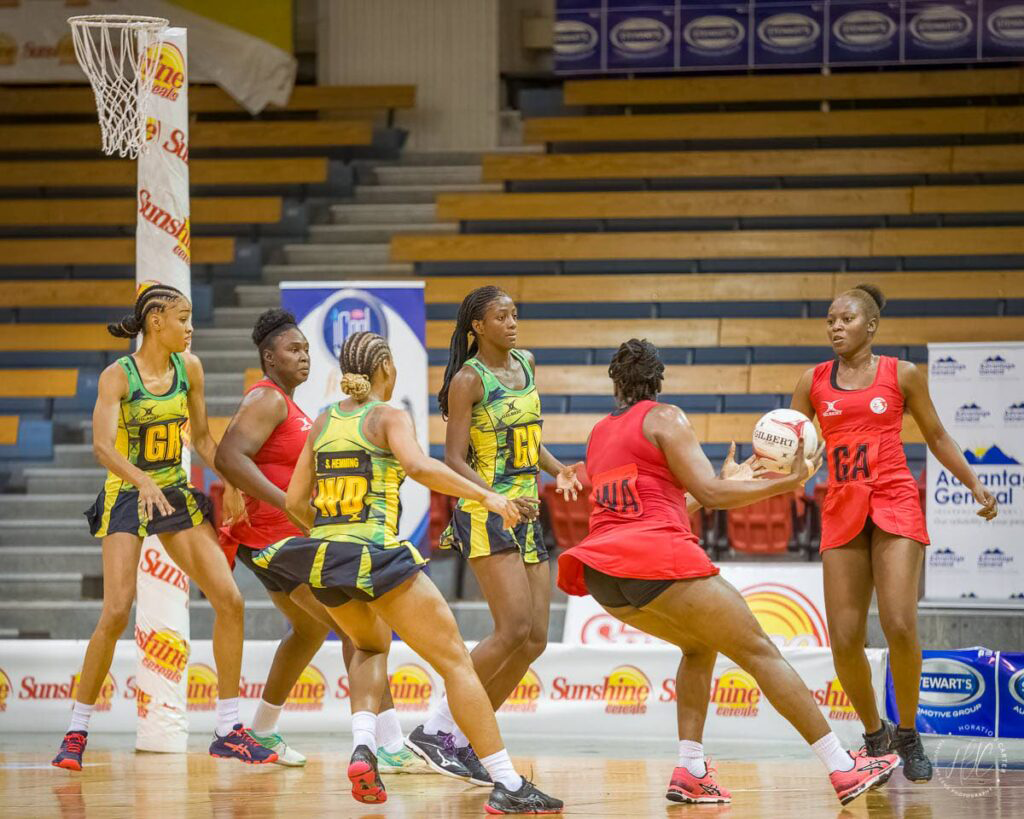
(558, 401), (718, 596)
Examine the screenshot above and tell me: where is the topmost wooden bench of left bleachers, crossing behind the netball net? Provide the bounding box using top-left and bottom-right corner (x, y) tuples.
(0, 85), (416, 117)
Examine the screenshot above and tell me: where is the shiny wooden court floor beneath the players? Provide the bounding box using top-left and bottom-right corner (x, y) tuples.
(0, 733), (1024, 819)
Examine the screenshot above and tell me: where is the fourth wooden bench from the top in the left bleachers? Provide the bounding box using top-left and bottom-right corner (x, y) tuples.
(0, 197), (282, 227)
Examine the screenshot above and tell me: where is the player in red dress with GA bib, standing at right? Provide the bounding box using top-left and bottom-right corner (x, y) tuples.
(792, 285), (996, 782)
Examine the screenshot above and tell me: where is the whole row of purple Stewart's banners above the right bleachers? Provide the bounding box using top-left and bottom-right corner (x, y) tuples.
(554, 0), (1024, 74)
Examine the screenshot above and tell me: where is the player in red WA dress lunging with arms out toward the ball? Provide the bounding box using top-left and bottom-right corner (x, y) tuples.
(558, 339), (898, 805)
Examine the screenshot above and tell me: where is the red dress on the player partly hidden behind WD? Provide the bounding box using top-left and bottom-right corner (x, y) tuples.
(218, 378), (312, 563)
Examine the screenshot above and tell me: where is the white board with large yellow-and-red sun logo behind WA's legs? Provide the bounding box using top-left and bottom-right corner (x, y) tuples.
(562, 563), (829, 648)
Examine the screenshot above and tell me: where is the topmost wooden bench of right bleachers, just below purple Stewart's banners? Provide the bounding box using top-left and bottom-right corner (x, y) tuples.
(563, 68), (1024, 105)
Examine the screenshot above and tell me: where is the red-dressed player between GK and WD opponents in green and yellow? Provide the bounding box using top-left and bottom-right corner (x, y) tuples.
(216, 309), (419, 773)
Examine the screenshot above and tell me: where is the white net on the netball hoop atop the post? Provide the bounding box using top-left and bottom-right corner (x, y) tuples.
(68, 14), (168, 159)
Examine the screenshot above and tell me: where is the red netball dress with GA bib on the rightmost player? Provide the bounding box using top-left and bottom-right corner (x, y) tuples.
(811, 355), (928, 552)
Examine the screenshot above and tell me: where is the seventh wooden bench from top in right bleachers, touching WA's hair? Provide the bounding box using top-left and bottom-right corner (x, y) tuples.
(417, 317), (1024, 349)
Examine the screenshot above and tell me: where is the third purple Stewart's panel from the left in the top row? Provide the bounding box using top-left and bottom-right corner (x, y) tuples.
(677, 3), (751, 69)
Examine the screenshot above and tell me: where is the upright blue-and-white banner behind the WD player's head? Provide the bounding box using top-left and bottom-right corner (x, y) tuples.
(281, 282), (430, 546)
